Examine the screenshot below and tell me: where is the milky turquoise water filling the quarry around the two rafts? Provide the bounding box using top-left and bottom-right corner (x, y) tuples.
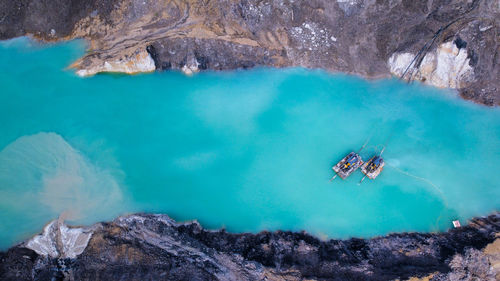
(0, 36), (500, 248)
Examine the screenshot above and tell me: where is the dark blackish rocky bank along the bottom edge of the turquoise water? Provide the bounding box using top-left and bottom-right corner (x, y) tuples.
(0, 213), (500, 280)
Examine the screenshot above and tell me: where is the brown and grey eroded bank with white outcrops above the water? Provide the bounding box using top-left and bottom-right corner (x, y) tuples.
(0, 0), (500, 105)
